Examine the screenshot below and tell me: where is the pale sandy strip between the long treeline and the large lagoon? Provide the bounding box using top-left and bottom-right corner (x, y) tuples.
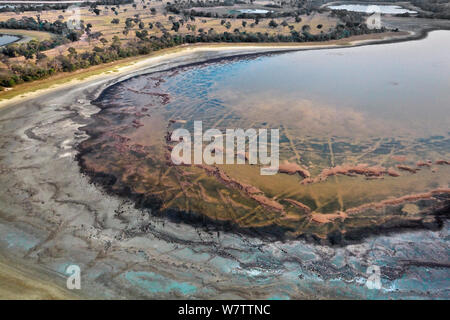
(0, 32), (421, 109)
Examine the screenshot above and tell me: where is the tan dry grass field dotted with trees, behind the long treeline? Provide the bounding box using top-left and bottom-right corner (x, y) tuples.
(0, 1), (338, 57)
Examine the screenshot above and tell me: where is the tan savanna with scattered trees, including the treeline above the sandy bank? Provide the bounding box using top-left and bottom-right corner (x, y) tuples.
(0, 0), (398, 90)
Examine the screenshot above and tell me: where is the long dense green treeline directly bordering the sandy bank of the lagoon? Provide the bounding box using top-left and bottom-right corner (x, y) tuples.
(0, 24), (386, 89)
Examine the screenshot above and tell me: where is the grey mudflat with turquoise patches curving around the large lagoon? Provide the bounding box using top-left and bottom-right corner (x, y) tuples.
(0, 28), (447, 299)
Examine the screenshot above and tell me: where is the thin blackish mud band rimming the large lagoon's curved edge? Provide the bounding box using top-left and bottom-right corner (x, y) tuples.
(72, 29), (449, 246)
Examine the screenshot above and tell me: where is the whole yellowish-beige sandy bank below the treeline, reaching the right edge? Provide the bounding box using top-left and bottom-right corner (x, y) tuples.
(5, 17), (450, 109)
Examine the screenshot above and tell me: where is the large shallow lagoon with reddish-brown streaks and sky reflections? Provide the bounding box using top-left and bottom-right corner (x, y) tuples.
(81, 31), (450, 241)
